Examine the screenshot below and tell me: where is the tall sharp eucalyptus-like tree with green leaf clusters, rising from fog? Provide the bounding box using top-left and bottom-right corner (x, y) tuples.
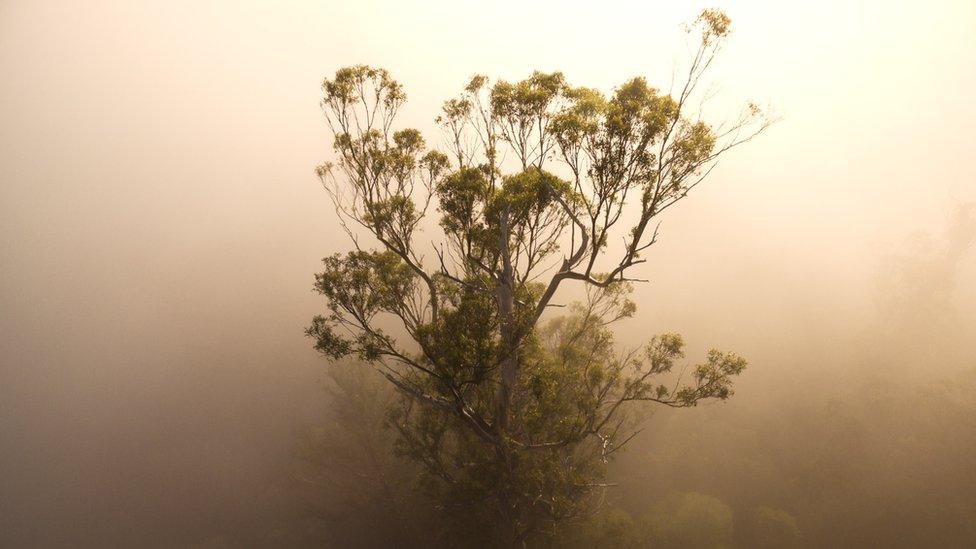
(307, 10), (770, 544)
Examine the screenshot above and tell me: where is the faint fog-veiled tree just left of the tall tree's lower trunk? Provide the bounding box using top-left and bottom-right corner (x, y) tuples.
(292, 360), (432, 547)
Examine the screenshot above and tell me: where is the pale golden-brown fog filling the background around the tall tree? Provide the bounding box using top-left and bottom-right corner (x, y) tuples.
(0, 0), (976, 547)
